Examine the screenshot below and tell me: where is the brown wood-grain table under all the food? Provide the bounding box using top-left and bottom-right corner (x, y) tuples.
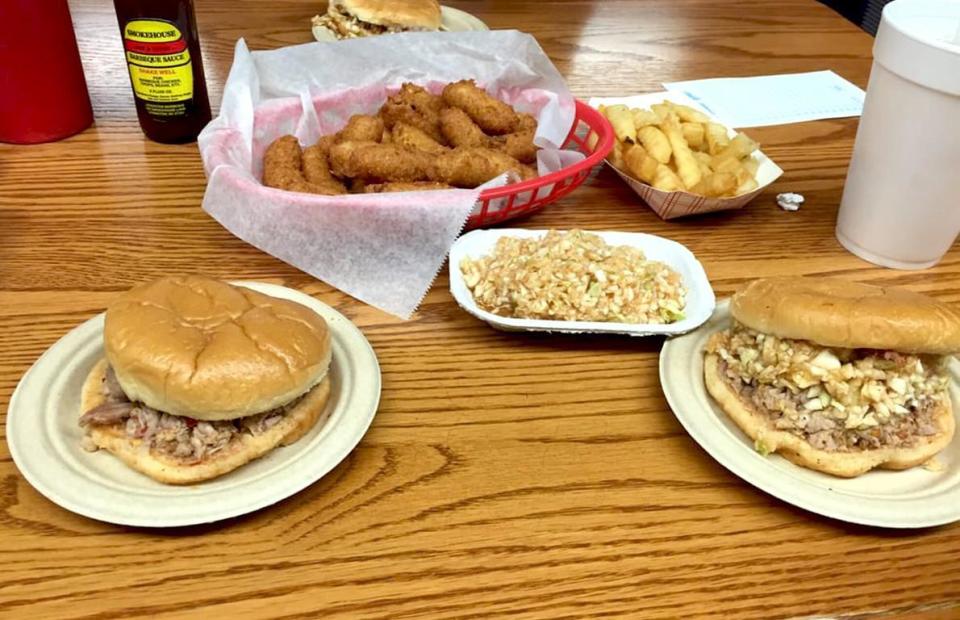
(0, 0), (960, 619)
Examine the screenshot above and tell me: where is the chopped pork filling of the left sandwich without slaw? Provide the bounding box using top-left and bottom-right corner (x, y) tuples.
(80, 368), (300, 463)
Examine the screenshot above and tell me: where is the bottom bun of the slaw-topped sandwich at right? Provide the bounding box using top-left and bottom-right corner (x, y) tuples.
(703, 353), (956, 478)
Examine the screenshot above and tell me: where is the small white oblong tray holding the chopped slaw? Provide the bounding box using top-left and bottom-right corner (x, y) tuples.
(450, 228), (716, 336)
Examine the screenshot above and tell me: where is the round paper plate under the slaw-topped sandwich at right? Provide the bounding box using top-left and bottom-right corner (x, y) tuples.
(660, 300), (960, 528)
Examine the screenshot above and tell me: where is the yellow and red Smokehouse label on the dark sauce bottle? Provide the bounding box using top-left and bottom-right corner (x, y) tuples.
(123, 19), (193, 106)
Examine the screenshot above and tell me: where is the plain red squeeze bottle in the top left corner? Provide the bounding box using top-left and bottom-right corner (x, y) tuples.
(0, 0), (93, 144)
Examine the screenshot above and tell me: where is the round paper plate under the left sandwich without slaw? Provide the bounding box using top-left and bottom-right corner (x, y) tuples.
(7, 282), (380, 527)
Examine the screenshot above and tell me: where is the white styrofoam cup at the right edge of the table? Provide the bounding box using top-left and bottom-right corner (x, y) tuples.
(836, 0), (960, 269)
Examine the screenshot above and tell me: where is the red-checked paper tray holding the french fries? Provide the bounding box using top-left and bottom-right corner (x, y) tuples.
(589, 91), (783, 220)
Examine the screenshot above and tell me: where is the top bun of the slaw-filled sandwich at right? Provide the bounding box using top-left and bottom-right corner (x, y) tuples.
(730, 277), (960, 355)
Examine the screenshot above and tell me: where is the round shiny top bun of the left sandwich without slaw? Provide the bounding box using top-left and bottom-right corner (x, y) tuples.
(103, 276), (331, 420)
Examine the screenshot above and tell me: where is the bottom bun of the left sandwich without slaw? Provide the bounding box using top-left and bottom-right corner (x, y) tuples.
(80, 359), (330, 484)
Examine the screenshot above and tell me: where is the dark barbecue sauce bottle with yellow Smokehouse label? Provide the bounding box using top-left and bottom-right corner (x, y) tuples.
(113, 0), (210, 143)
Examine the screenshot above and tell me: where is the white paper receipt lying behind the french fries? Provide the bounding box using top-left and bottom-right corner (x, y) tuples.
(664, 71), (866, 127)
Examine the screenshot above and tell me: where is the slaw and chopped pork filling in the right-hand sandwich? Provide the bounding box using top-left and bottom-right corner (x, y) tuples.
(707, 323), (947, 452)
